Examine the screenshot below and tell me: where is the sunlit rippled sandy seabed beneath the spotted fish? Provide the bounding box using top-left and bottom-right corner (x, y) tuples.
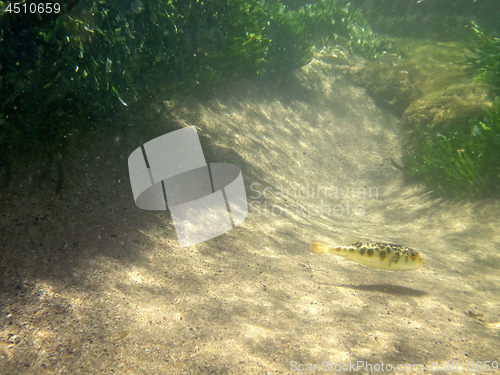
(0, 49), (500, 374)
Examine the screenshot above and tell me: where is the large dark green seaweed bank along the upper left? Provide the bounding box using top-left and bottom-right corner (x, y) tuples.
(0, 0), (383, 153)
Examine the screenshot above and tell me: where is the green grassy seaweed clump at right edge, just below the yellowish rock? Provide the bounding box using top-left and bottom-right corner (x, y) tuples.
(394, 97), (500, 198)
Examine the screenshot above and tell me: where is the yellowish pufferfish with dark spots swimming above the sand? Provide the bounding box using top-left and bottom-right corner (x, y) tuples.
(311, 241), (424, 271)
